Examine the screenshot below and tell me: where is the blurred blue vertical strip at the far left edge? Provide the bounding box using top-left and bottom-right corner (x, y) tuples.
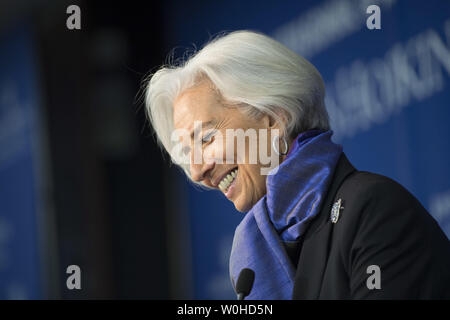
(0, 27), (43, 299)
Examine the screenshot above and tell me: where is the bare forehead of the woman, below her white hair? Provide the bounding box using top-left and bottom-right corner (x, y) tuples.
(173, 81), (220, 130)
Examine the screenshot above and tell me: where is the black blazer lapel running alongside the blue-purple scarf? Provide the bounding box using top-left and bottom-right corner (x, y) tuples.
(293, 153), (356, 299)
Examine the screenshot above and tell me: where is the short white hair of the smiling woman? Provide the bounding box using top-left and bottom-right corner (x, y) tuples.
(145, 30), (329, 182)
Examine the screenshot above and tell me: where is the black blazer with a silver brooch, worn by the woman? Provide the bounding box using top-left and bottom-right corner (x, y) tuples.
(289, 154), (450, 299)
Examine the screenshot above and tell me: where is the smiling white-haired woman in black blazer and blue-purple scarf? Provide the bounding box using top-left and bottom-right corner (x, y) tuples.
(146, 31), (450, 299)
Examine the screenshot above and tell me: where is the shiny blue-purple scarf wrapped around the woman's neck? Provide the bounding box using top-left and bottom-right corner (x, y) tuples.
(230, 130), (342, 300)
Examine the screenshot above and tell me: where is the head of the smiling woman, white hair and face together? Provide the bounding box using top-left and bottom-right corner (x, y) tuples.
(147, 31), (329, 211)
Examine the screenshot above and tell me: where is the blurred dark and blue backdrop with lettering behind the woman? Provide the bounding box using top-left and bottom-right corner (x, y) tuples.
(0, 0), (450, 299)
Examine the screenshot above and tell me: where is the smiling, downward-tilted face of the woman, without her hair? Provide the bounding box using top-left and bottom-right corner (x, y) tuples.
(173, 80), (283, 212)
